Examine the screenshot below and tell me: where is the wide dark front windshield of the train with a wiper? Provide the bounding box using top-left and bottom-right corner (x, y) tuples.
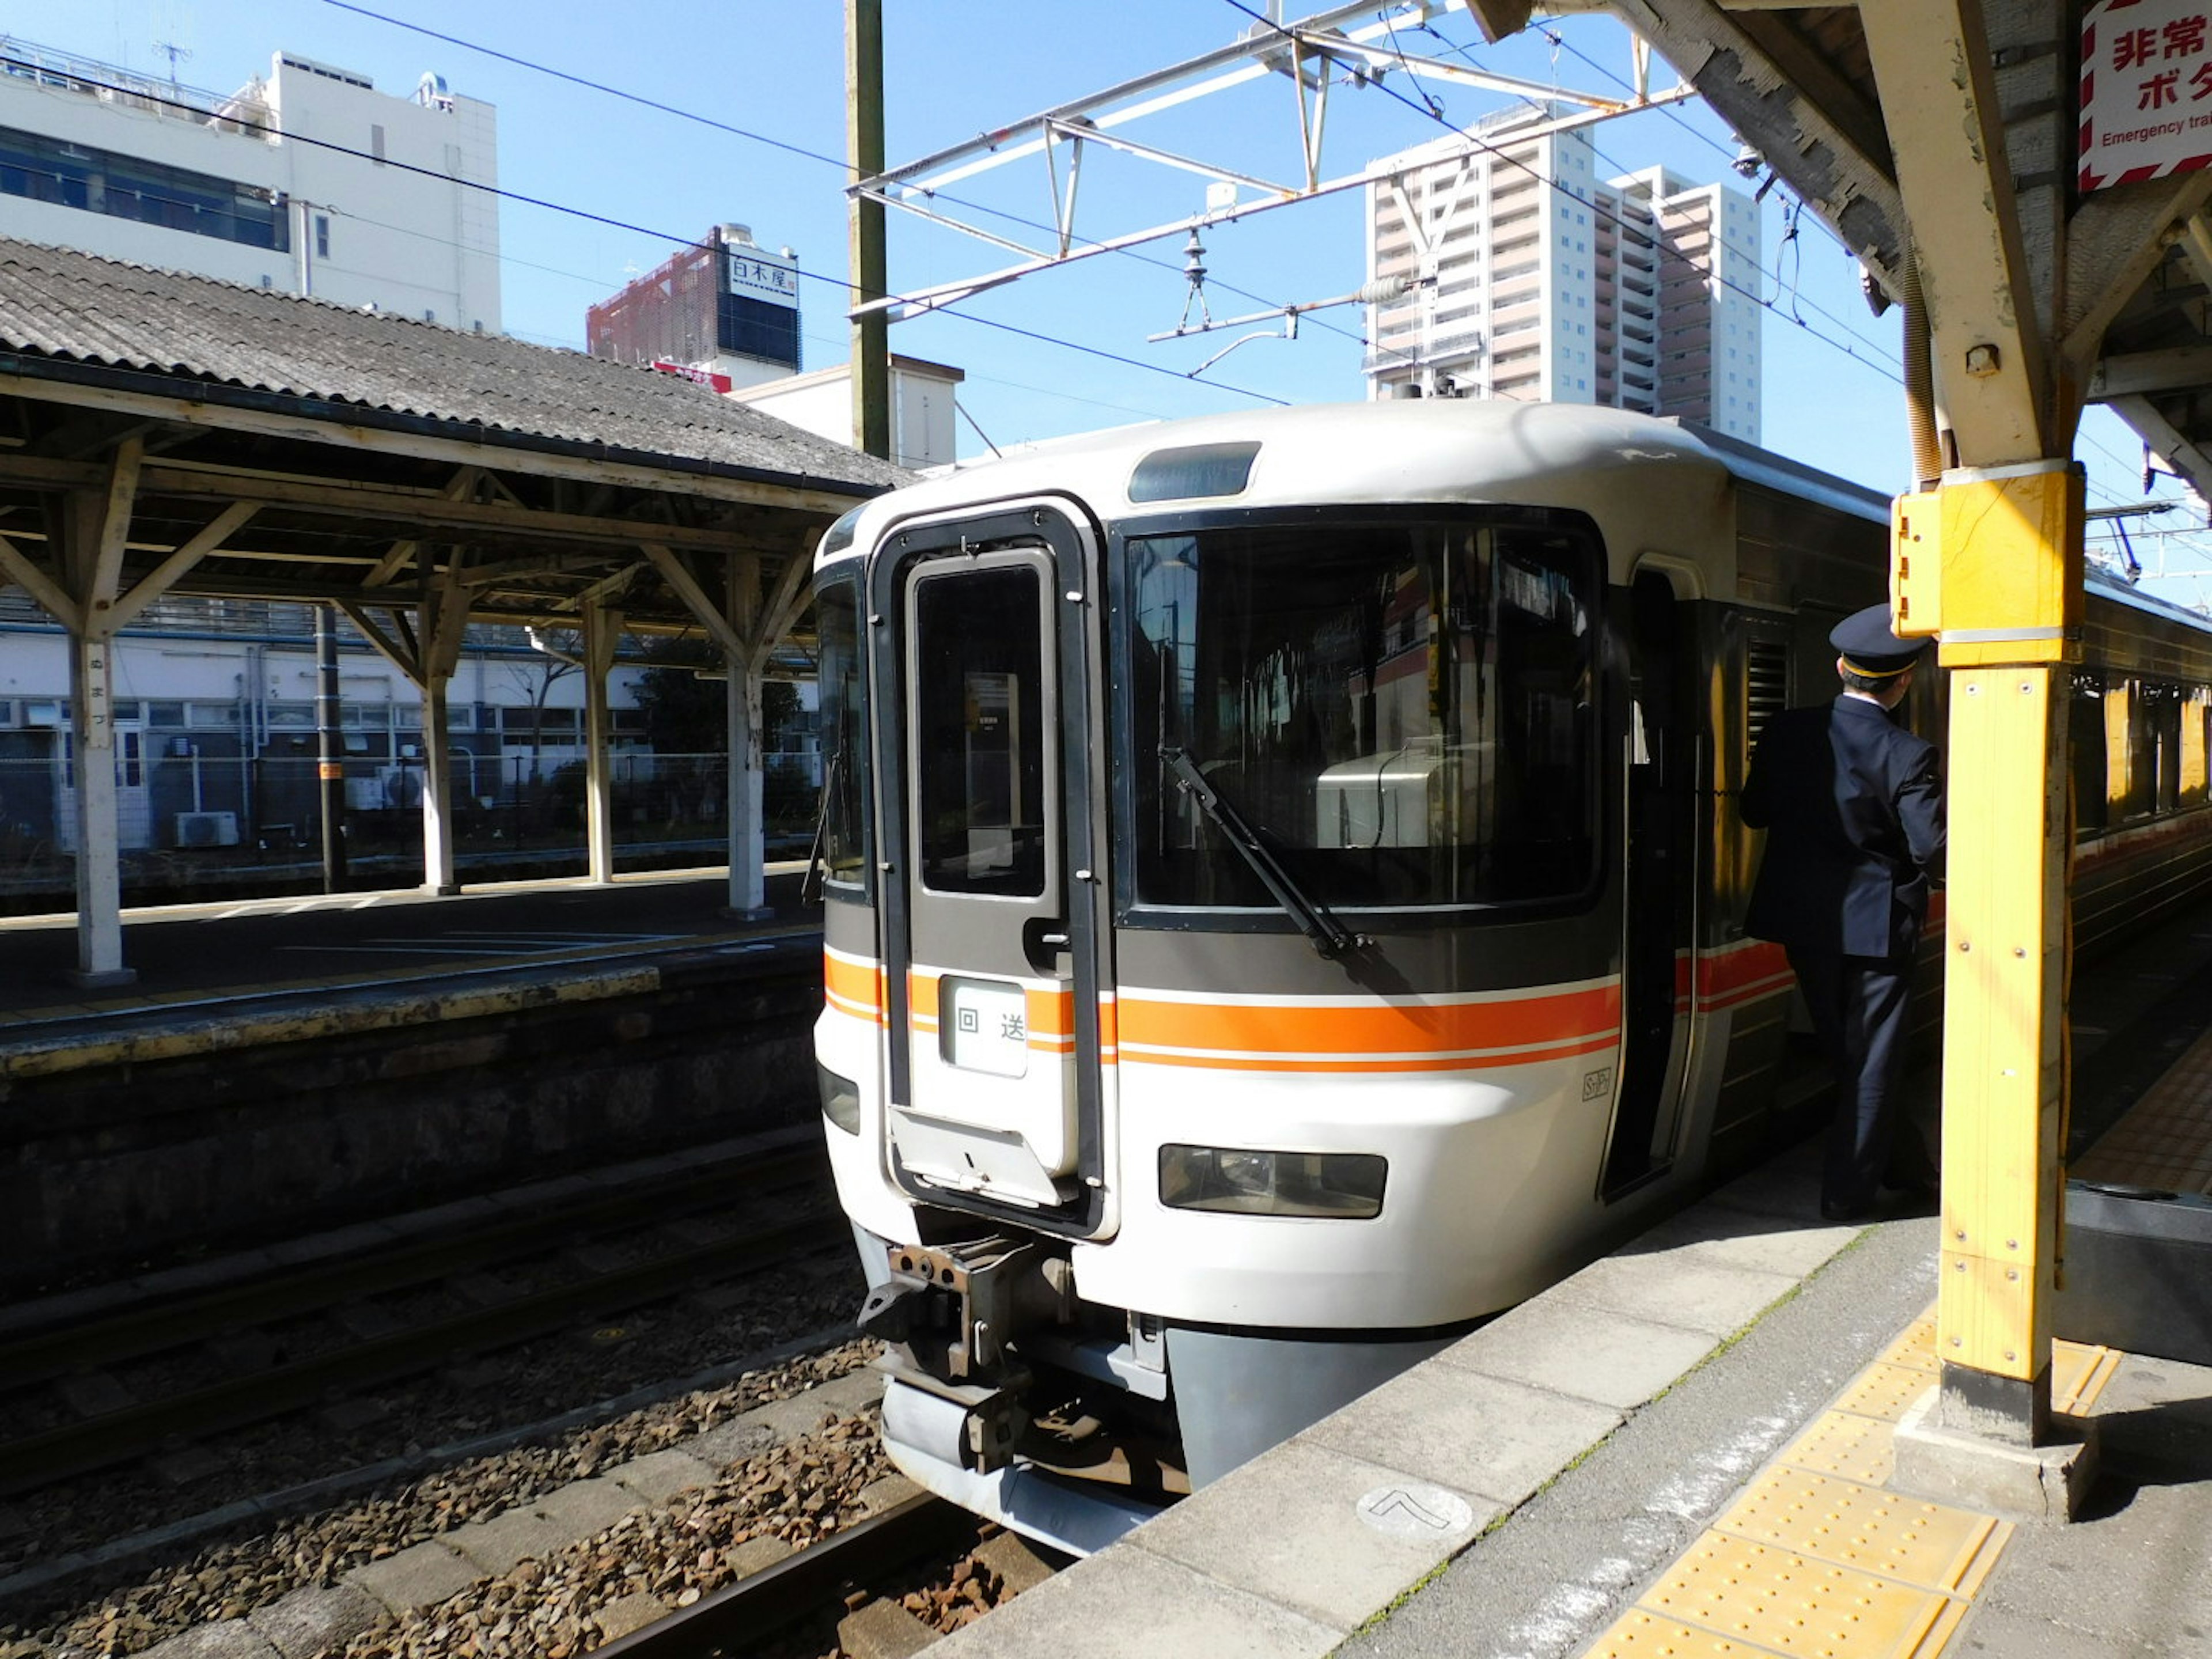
(1122, 511), (1604, 909)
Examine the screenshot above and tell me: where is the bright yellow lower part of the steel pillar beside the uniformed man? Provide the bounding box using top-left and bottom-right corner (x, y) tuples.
(1891, 460), (2081, 1446)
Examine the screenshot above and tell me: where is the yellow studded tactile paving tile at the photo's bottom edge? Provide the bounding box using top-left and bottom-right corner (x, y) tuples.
(1643, 1533), (1967, 1659)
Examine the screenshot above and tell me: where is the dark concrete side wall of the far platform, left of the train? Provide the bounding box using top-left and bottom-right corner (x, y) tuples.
(0, 951), (821, 1294)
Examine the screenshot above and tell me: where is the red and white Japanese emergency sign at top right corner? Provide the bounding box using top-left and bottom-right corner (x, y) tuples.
(2080, 0), (2212, 190)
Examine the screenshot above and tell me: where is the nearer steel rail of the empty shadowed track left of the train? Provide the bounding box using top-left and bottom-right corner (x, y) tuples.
(0, 1212), (847, 1495)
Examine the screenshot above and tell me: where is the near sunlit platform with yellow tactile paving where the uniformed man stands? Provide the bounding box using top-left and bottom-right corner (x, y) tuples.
(931, 909), (2212, 1659)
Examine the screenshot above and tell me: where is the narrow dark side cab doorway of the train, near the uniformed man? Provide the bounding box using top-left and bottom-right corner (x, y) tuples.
(1601, 569), (1703, 1199)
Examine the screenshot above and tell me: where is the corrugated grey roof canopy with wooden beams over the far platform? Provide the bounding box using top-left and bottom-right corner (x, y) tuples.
(0, 239), (907, 653)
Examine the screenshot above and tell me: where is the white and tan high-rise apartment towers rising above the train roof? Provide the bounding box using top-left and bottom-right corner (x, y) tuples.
(1367, 106), (1761, 442)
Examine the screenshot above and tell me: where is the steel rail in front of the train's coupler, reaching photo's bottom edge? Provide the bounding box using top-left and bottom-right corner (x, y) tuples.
(593, 1493), (978, 1659)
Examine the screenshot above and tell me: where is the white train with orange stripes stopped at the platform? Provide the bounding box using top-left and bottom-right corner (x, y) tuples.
(816, 400), (2212, 1551)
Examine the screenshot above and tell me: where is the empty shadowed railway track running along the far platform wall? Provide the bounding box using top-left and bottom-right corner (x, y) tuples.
(0, 1130), (845, 1495)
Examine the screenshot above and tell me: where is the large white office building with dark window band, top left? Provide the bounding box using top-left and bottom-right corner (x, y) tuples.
(0, 40), (500, 332)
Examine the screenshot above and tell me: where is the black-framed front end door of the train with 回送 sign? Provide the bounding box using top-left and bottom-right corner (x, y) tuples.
(872, 509), (1104, 1232)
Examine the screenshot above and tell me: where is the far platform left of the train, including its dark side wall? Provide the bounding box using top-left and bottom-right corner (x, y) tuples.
(0, 869), (821, 1294)
